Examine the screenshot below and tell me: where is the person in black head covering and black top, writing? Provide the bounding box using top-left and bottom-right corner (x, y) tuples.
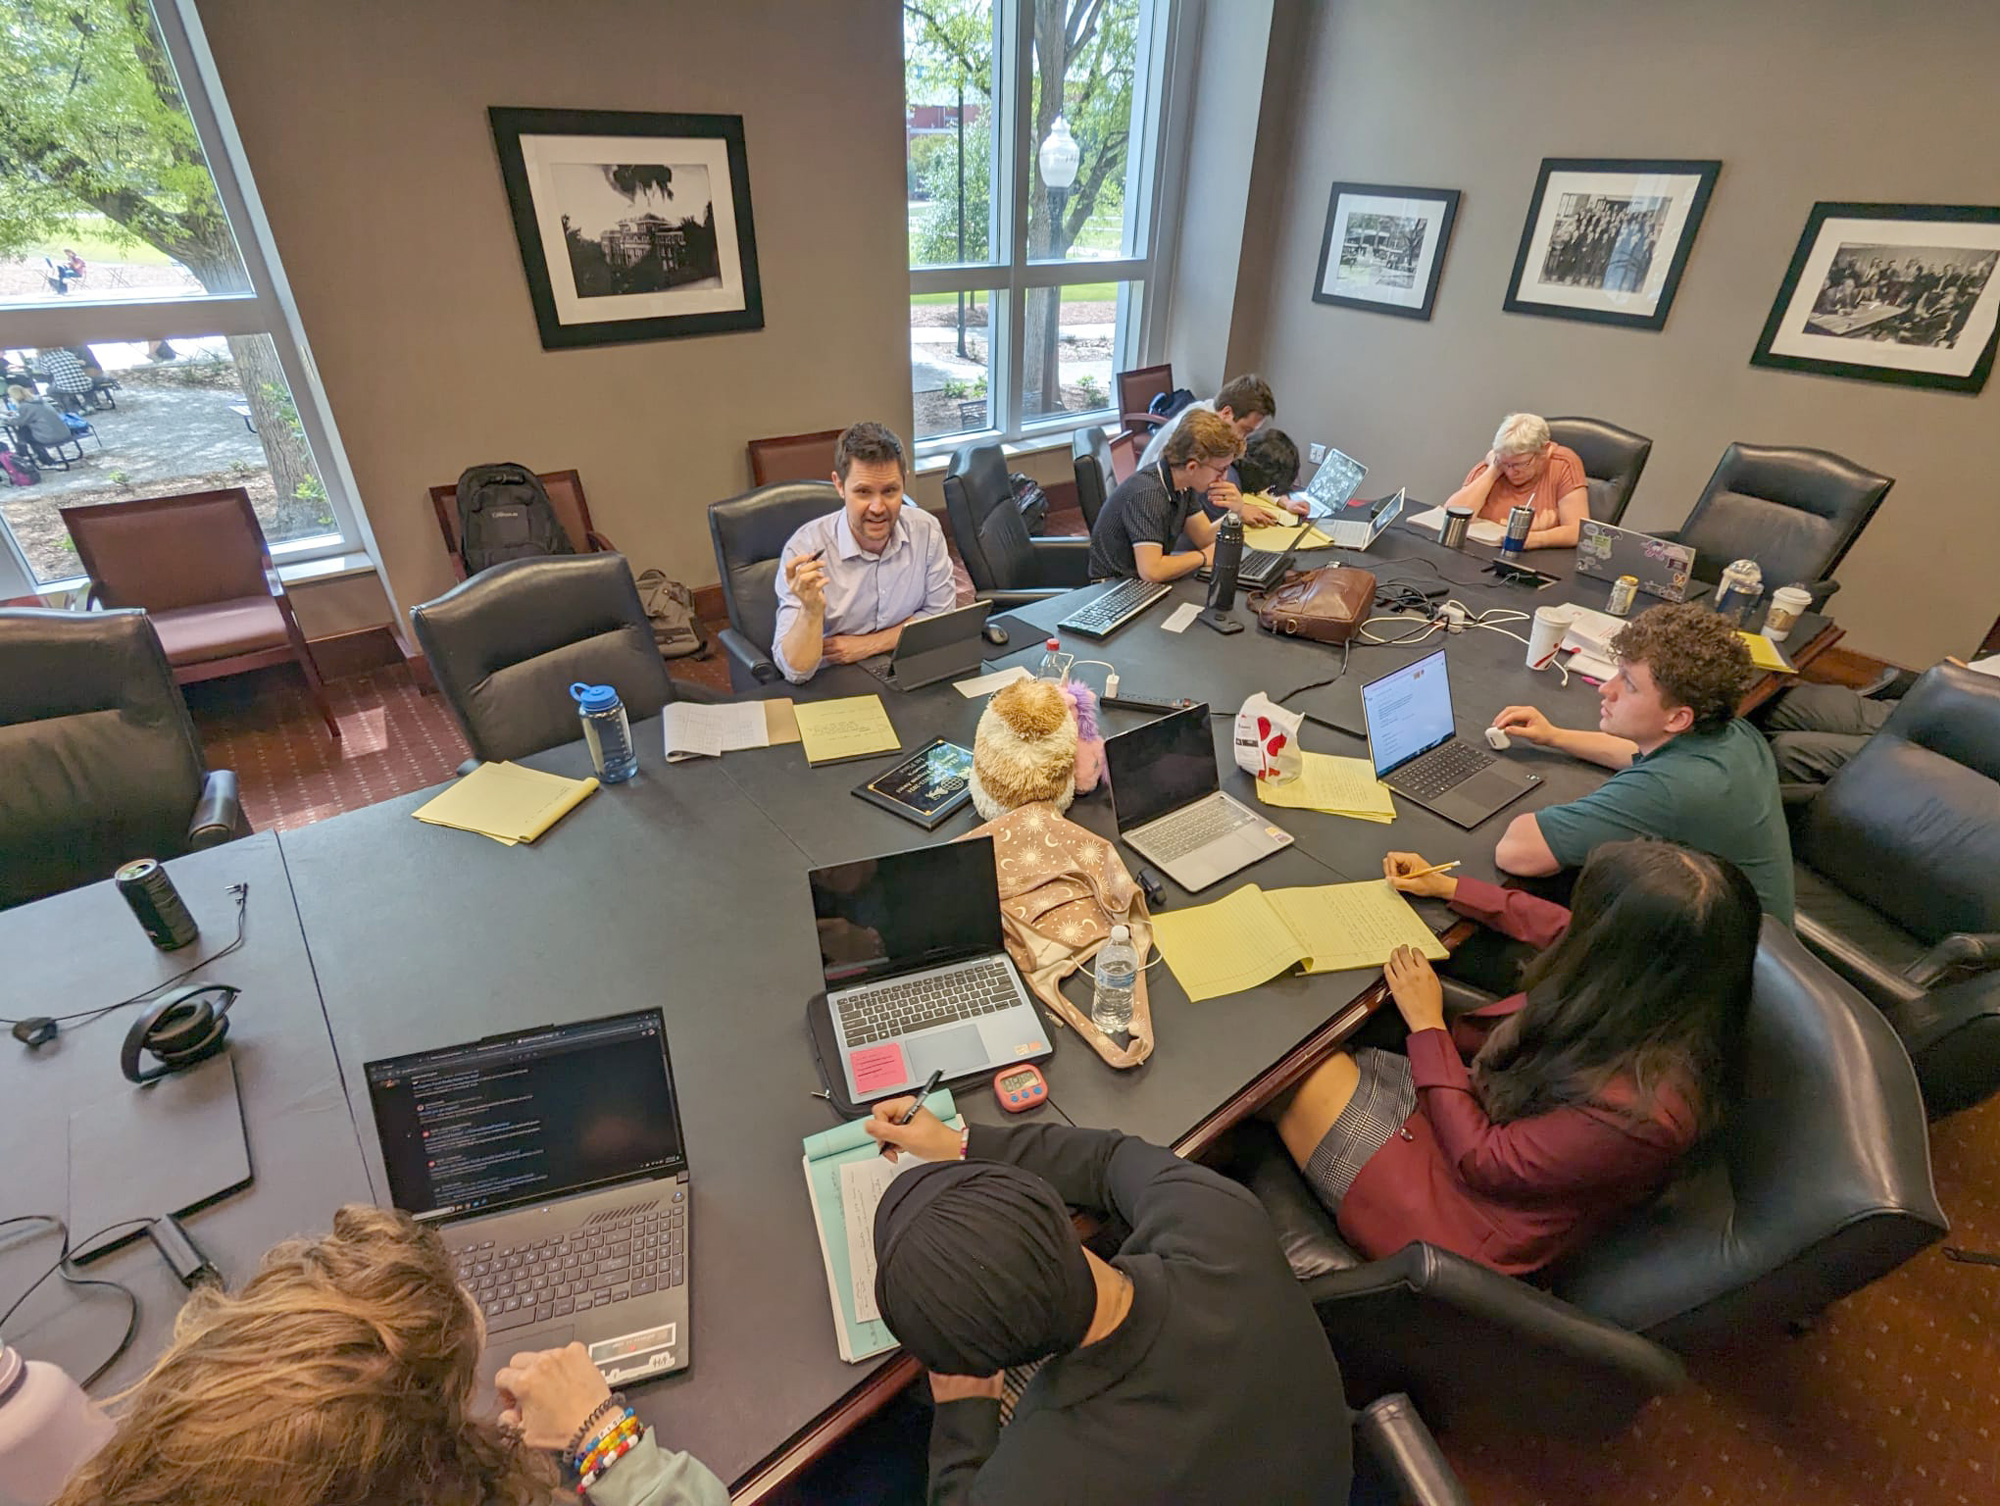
(868, 1098), (1352, 1506)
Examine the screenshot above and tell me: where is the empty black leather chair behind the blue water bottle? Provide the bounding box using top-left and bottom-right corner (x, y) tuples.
(410, 554), (708, 762)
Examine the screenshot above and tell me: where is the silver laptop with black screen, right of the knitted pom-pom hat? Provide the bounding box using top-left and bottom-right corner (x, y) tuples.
(1104, 706), (1292, 892)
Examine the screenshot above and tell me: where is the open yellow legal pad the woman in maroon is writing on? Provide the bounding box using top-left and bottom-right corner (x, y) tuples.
(1152, 878), (1450, 1000)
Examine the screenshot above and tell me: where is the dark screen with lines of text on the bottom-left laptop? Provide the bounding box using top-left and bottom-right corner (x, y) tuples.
(368, 1010), (682, 1218)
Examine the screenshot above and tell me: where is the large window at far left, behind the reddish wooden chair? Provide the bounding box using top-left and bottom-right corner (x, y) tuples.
(0, 0), (360, 598)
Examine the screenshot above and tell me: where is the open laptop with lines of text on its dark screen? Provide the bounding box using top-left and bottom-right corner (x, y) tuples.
(364, 1010), (692, 1386)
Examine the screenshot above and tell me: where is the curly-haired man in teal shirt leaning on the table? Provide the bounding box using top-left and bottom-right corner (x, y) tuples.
(1494, 604), (1792, 924)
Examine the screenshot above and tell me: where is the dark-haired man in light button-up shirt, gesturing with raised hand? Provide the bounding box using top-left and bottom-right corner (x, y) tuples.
(770, 424), (958, 684)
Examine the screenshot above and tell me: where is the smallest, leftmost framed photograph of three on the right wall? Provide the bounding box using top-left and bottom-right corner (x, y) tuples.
(1312, 184), (1458, 318)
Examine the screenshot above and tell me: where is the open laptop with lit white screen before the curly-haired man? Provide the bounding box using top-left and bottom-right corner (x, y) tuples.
(1362, 648), (1542, 830)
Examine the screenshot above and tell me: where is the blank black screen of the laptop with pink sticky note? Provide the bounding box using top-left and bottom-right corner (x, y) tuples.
(812, 836), (1004, 988)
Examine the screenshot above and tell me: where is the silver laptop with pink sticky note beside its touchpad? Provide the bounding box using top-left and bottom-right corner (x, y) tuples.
(810, 836), (1050, 1104)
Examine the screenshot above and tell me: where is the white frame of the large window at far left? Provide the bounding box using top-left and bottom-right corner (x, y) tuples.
(0, 0), (380, 598)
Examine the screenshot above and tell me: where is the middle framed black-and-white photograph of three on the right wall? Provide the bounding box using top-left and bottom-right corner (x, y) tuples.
(1506, 156), (1722, 330)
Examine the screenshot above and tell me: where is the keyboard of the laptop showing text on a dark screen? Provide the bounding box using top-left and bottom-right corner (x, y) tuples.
(452, 1186), (688, 1334)
